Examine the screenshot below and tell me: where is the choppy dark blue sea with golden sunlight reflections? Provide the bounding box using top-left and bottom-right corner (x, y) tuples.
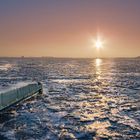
(0, 58), (140, 140)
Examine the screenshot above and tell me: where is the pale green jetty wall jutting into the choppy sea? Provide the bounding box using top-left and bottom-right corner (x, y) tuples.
(0, 82), (43, 111)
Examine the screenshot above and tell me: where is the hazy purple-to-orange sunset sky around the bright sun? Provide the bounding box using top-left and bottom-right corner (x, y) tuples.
(0, 0), (140, 58)
